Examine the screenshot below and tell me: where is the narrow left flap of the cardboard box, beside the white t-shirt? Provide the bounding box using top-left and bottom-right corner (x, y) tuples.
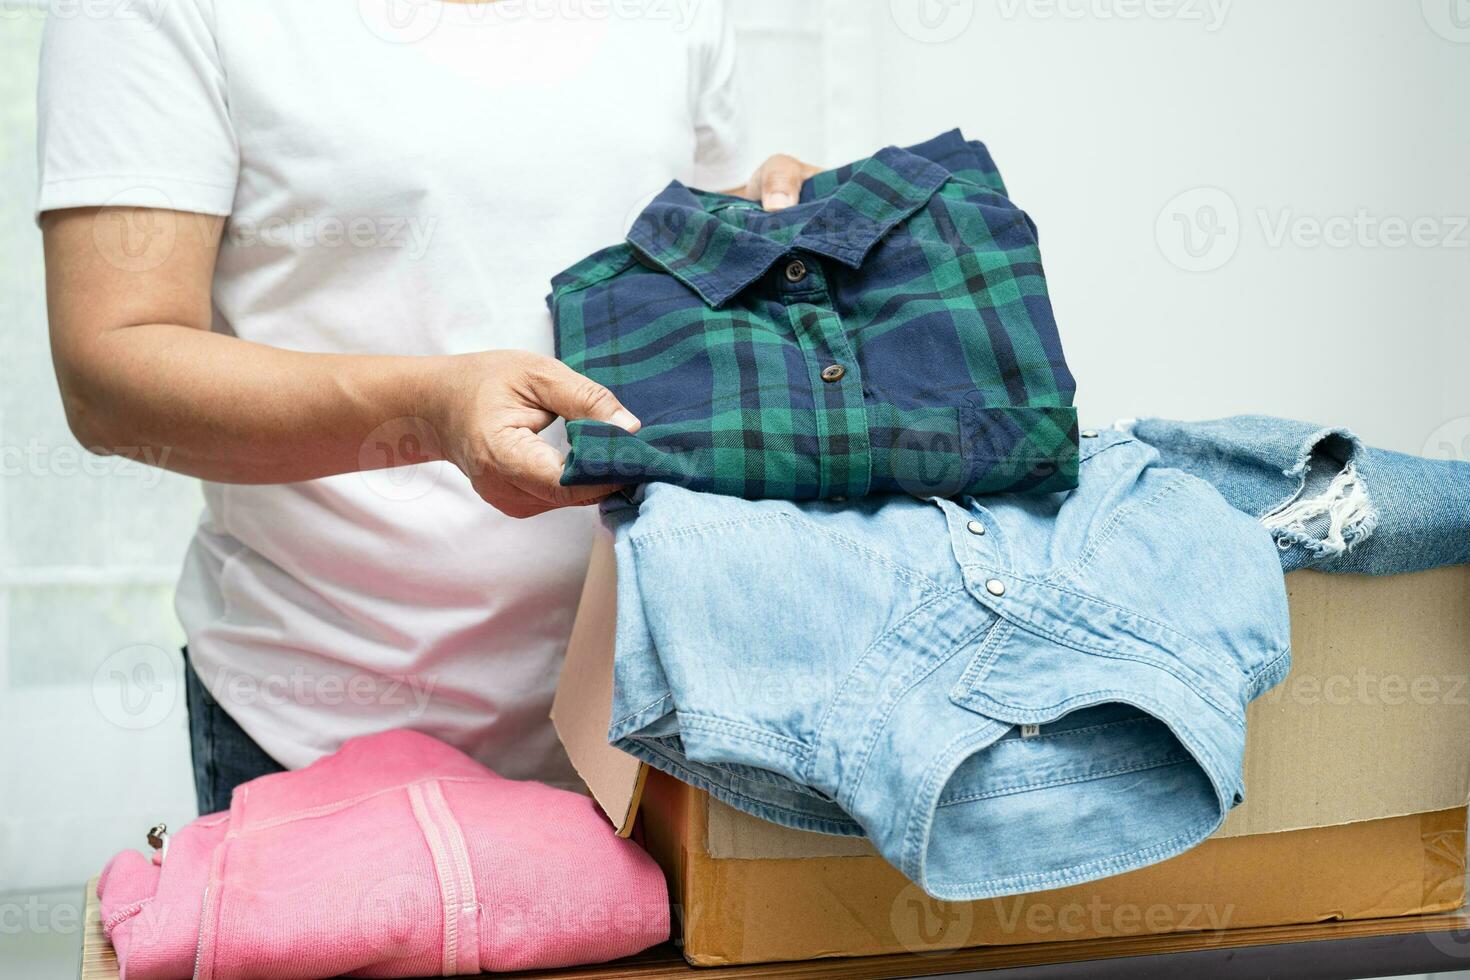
(551, 527), (644, 837)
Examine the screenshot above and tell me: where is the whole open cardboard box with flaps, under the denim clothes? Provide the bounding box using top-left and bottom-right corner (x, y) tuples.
(553, 533), (1470, 965)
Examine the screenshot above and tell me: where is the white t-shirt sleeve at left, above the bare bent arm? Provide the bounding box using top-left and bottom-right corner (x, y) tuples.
(35, 0), (240, 216)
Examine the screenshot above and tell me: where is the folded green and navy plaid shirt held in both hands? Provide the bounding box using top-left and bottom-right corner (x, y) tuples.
(548, 131), (1078, 500)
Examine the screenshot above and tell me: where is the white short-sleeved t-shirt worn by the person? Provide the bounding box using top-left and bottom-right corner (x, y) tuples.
(37, 0), (750, 782)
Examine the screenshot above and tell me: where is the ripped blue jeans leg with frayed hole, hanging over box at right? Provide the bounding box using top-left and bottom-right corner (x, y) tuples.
(1117, 416), (1470, 574)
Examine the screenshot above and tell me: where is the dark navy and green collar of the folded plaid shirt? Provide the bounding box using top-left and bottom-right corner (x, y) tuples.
(628, 142), (958, 309)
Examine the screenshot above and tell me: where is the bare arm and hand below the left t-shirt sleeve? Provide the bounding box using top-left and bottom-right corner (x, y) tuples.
(41, 207), (638, 517)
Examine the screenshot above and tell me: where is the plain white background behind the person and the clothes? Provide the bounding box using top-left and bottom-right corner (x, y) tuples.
(0, 0), (1470, 975)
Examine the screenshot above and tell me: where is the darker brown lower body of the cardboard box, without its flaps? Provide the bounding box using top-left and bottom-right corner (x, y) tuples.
(642, 770), (1466, 965)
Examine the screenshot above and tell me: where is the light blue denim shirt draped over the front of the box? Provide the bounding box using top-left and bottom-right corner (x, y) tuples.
(604, 430), (1289, 899)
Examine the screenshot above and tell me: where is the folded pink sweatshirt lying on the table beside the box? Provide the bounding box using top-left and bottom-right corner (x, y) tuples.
(97, 730), (669, 980)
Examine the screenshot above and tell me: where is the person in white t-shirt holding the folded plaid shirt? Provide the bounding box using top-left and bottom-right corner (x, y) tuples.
(38, 0), (811, 813)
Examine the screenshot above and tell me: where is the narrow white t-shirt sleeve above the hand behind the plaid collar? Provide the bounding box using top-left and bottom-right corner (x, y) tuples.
(694, 1), (756, 190)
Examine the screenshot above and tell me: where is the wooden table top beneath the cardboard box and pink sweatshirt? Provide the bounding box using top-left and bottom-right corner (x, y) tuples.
(79, 879), (1470, 980)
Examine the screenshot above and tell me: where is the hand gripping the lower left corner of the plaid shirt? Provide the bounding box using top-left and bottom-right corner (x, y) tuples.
(425, 351), (641, 517)
